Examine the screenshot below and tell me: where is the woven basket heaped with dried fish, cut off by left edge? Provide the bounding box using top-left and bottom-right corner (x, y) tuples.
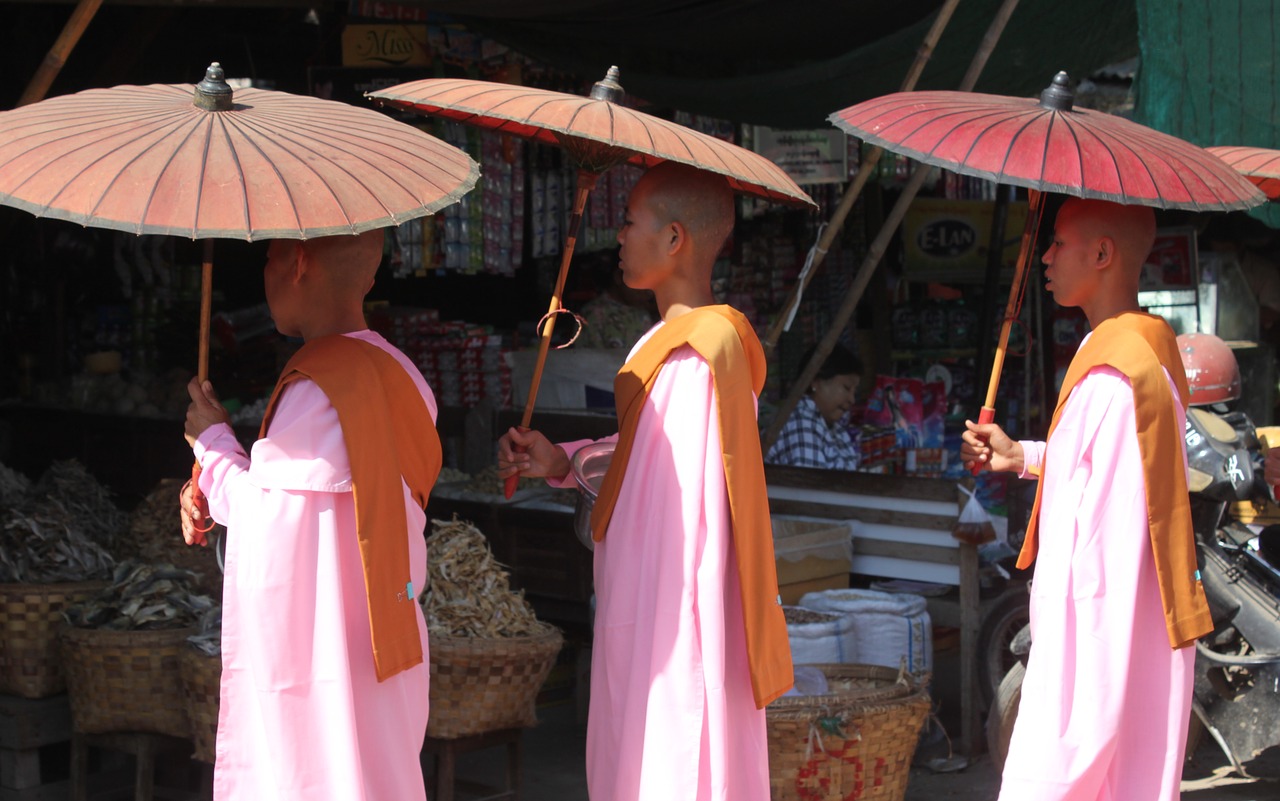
(0, 462), (120, 699)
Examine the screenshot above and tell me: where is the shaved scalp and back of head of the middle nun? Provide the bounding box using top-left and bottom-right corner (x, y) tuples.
(636, 161), (733, 258)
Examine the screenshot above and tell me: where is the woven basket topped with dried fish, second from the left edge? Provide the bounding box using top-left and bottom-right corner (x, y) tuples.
(61, 560), (216, 737)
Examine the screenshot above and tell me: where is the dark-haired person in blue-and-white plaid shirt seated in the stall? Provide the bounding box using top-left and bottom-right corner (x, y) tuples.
(764, 344), (863, 470)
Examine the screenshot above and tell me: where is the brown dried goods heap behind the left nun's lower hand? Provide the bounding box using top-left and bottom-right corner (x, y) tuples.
(118, 479), (225, 598)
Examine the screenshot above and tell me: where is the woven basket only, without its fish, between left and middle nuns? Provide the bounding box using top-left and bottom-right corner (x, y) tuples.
(426, 626), (564, 740)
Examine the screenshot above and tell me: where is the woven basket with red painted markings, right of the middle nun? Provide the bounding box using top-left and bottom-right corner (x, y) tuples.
(765, 664), (929, 801)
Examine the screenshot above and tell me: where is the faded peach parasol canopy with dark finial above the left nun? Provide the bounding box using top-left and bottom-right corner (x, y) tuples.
(0, 63), (479, 239)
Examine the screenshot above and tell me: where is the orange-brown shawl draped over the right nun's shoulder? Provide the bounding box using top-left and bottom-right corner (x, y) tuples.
(1018, 312), (1213, 649)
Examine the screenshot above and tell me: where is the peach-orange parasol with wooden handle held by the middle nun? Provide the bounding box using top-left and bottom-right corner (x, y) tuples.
(369, 67), (814, 498)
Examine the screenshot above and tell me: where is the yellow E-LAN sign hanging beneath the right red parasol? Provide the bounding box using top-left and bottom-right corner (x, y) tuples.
(902, 197), (1027, 283)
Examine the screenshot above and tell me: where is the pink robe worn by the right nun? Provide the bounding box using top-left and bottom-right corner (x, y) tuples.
(1000, 367), (1196, 801)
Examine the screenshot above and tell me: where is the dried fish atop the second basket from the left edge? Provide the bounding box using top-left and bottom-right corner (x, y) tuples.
(63, 559), (215, 631)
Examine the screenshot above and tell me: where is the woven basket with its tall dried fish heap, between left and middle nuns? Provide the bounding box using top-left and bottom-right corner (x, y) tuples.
(421, 518), (562, 738)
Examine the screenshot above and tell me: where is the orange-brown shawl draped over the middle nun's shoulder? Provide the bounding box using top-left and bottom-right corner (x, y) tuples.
(591, 306), (794, 709)
